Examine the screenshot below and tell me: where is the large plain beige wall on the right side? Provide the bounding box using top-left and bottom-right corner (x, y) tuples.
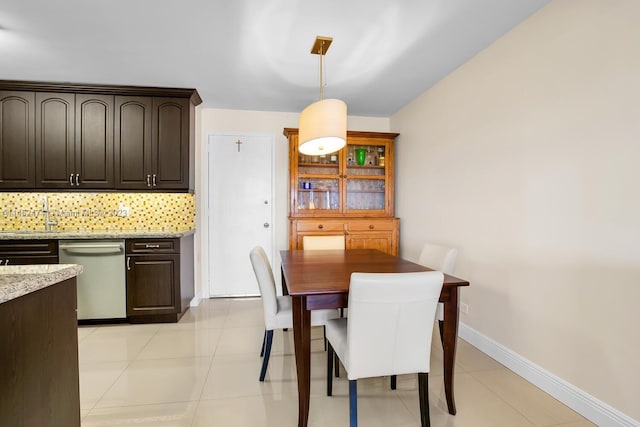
(391, 0), (640, 419)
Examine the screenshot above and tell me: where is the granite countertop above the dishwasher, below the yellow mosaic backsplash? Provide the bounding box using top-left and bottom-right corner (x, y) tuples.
(0, 230), (195, 240)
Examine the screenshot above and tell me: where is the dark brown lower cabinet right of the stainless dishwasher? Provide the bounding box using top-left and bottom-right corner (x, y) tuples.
(126, 235), (194, 323)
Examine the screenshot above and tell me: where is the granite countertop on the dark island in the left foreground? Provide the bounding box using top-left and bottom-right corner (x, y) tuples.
(0, 264), (82, 304)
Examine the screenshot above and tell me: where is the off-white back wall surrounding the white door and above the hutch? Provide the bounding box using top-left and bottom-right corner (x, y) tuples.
(196, 108), (389, 296)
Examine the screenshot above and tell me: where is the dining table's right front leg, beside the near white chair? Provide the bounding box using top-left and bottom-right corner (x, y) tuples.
(442, 286), (460, 415)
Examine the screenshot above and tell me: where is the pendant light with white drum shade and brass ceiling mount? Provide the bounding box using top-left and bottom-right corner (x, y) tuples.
(298, 36), (347, 156)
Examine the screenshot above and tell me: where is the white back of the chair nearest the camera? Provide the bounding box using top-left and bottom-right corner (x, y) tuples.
(345, 271), (444, 380)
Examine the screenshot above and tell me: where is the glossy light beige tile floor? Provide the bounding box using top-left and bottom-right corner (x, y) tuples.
(78, 299), (593, 427)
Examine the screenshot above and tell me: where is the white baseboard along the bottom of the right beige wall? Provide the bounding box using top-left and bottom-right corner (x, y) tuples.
(458, 322), (640, 427)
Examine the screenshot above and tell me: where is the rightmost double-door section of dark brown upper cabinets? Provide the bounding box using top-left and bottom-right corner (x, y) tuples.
(115, 96), (191, 190)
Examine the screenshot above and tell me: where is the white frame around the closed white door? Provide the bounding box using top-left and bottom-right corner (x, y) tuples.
(202, 132), (277, 299)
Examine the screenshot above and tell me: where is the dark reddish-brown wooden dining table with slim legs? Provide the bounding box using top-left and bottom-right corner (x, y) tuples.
(280, 249), (469, 427)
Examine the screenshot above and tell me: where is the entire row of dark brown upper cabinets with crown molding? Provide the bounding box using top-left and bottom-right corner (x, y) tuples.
(0, 80), (202, 191)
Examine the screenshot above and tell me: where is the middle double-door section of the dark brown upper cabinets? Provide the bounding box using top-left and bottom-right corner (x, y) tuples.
(36, 92), (114, 189)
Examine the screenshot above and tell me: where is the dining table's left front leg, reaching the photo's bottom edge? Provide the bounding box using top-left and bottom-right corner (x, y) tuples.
(291, 296), (311, 427)
